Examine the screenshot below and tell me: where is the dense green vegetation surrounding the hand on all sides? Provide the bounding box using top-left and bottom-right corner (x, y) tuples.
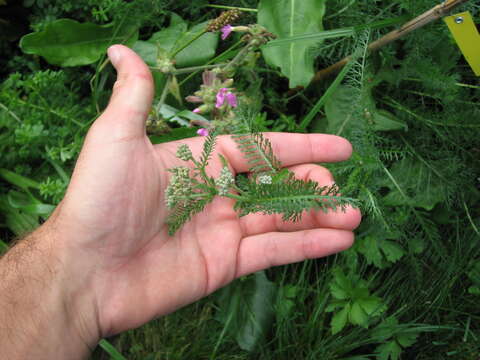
(0, 0), (480, 360)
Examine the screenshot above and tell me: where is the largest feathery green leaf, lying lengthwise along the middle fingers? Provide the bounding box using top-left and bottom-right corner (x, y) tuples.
(235, 172), (355, 221)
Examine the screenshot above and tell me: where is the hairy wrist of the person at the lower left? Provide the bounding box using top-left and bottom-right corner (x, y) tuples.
(0, 222), (99, 359)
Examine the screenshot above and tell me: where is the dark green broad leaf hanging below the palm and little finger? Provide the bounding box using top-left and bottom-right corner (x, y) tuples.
(217, 271), (277, 351)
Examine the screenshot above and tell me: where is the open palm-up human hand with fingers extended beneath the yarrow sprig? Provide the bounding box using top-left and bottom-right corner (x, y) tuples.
(43, 45), (360, 340)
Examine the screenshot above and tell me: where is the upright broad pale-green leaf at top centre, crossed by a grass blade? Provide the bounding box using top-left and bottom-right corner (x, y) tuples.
(258, 0), (326, 88)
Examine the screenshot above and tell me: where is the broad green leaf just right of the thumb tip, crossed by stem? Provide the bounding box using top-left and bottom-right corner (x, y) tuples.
(133, 14), (218, 68)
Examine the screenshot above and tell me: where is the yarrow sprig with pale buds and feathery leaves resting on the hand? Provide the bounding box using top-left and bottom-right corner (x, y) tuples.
(165, 127), (356, 235)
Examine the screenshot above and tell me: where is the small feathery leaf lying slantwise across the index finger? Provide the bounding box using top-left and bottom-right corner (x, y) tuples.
(232, 133), (281, 174)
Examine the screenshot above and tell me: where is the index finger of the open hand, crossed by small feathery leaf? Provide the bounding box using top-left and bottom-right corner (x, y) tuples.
(217, 132), (352, 173)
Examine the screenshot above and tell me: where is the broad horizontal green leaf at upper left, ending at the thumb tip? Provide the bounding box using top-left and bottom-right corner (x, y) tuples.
(20, 19), (138, 66)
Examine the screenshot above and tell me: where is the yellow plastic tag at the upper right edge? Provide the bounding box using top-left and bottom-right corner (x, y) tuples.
(445, 11), (480, 76)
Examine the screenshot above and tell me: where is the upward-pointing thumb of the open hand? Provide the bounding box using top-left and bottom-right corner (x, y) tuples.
(97, 45), (154, 138)
